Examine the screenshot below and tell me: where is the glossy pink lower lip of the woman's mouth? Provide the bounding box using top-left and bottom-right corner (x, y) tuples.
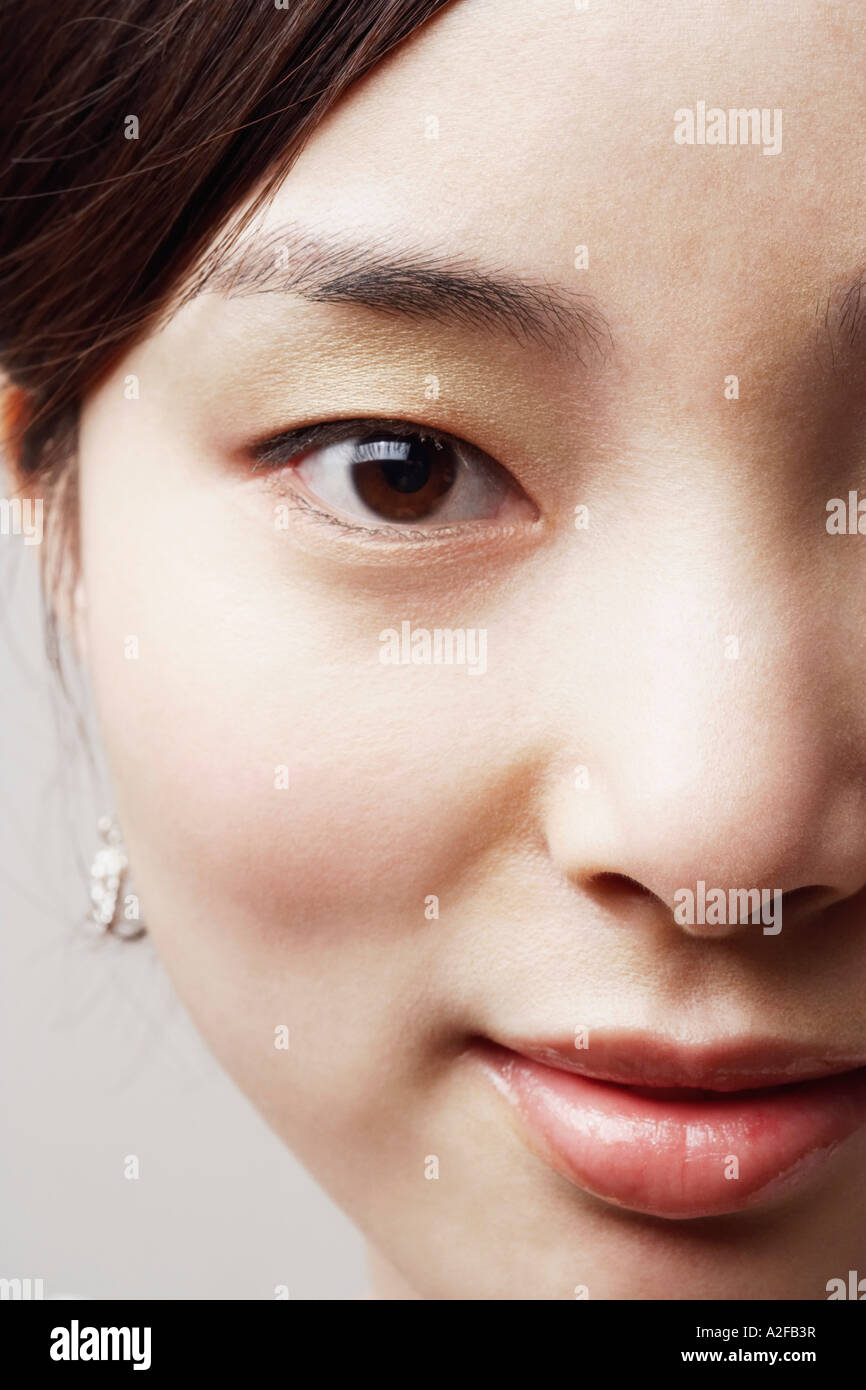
(477, 1044), (866, 1219)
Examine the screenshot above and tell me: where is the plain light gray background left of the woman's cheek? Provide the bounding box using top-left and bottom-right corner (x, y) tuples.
(0, 517), (366, 1298)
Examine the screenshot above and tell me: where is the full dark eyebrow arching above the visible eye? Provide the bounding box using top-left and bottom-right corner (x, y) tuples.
(183, 225), (613, 366)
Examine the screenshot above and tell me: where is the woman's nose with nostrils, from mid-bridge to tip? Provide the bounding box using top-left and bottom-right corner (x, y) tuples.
(545, 567), (866, 937)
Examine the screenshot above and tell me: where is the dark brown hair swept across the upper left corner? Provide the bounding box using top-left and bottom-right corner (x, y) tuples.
(0, 0), (445, 547)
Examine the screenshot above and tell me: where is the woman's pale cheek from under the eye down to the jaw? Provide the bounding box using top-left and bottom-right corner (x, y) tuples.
(82, 436), (522, 1166)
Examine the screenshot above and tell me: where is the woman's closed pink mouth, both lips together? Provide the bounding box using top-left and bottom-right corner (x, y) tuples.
(470, 1033), (866, 1219)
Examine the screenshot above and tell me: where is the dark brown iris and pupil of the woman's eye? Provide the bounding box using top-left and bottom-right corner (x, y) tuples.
(352, 435), (457, 521)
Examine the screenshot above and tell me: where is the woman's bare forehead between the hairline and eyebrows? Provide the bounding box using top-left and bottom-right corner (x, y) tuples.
(241, 0), (866, 360)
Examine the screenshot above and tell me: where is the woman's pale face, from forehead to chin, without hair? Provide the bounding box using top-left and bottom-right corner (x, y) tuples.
(81, 0), (866, 1298)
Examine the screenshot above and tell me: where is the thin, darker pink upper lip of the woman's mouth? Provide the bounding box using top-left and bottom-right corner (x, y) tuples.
(489, 1029), (866, 1091)
